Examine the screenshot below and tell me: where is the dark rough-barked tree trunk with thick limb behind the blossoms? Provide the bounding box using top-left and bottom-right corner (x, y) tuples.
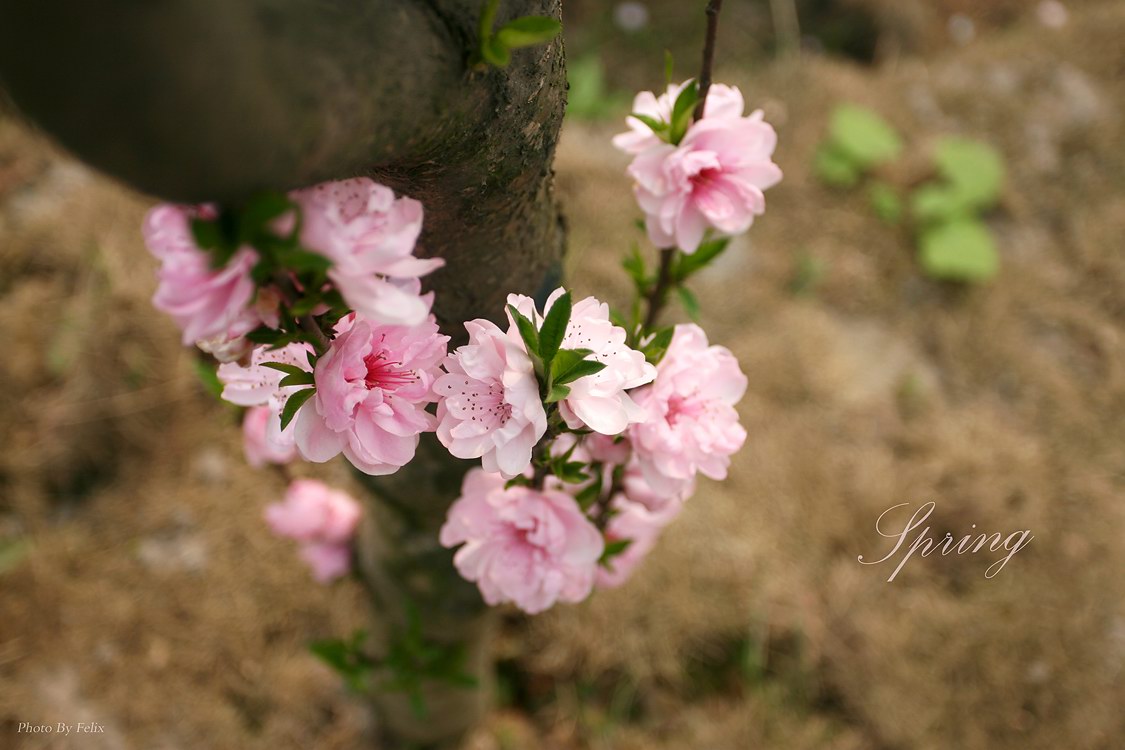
(0, 0), (566, 747)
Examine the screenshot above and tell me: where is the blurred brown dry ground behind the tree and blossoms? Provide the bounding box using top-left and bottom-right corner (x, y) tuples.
(0, 0), (1125, 750)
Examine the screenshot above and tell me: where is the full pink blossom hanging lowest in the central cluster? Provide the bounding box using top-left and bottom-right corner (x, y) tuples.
(440, 469), (604, 614)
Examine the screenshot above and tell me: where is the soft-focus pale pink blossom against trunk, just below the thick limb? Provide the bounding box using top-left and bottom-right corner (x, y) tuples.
(291, 178), (444, 325)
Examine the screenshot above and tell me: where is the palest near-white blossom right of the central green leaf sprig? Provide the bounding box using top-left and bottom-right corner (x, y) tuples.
(507, 288), (656, 435)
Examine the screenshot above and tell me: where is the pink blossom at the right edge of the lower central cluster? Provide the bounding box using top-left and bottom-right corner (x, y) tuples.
(629, 325), (747, 495)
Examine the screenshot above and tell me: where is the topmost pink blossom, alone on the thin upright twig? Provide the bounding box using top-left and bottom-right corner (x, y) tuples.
(613, 81), (782, 253)
